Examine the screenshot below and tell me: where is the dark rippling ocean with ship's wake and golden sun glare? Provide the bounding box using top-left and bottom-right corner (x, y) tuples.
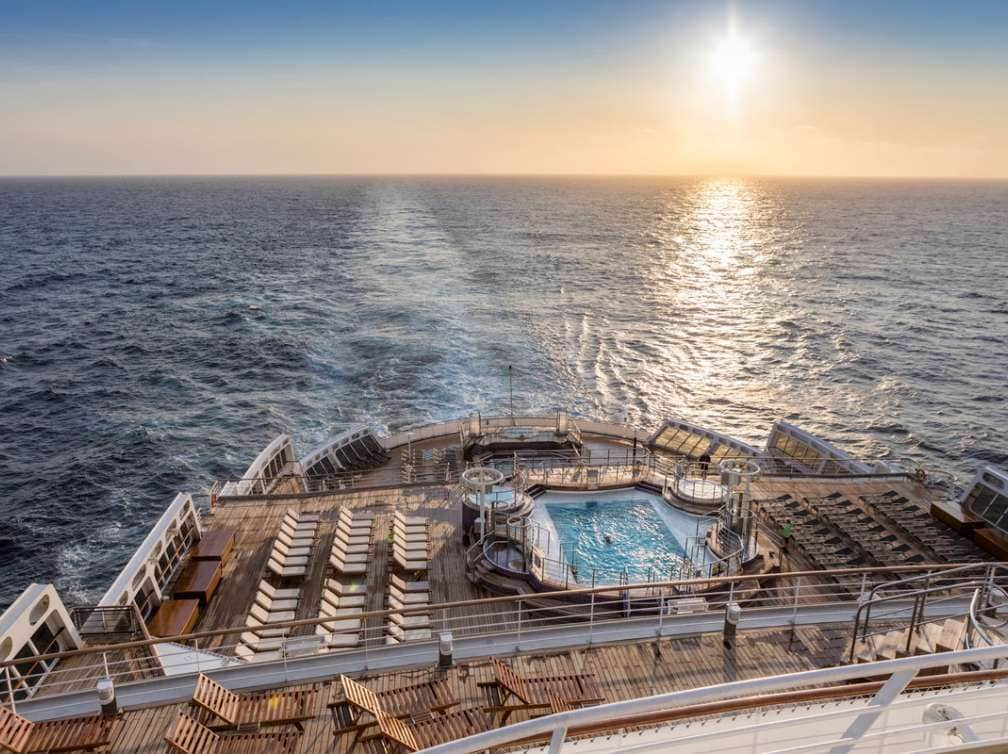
(0, 177), (1008, 607)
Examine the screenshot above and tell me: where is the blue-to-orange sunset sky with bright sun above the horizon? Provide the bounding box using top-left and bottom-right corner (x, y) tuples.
(0, 0), (1008, 178)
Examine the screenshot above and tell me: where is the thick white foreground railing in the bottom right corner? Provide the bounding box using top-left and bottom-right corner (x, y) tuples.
(424, 644), (1008, 754)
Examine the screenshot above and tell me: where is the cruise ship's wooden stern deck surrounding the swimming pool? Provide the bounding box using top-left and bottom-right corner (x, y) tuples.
(0, 418), (1008, 752)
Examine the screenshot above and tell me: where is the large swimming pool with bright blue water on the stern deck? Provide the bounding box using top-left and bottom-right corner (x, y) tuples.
(534, 490), (710, 584)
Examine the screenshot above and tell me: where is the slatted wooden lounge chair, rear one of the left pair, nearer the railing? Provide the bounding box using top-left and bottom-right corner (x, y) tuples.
(193, 673), (319, 732)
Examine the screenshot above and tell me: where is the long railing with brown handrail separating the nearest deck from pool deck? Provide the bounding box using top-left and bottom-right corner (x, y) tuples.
(0, 566), (983, 701)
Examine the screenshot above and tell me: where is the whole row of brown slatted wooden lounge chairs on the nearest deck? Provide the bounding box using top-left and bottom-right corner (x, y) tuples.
(9, 659), (605, 754)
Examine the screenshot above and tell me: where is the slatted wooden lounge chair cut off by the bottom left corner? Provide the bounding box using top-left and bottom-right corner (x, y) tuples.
(0, 706), (115, 754)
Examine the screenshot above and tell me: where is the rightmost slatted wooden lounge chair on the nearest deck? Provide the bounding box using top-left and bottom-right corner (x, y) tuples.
(479, 657), (606, 725)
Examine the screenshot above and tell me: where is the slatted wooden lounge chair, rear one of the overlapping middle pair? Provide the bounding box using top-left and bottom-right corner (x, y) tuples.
(327, 675), (459, 750)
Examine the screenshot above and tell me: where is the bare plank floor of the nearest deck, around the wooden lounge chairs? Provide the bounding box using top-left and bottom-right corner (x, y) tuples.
(96, 626), (849, 754)
